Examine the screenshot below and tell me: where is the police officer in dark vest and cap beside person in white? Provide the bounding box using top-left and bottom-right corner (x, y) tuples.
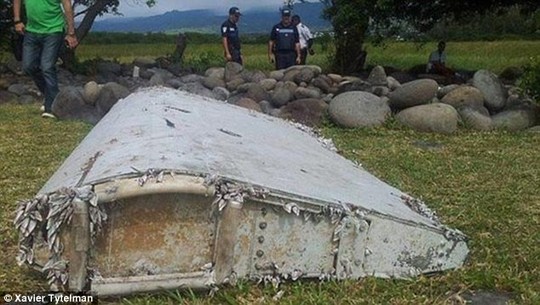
(268, 9), (300, 70)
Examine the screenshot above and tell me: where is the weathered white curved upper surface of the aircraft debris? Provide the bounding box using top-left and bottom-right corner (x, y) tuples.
(40, 88), (438, 225)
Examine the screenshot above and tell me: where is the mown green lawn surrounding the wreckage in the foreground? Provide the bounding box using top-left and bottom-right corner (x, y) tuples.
(0, 104), (540, 305)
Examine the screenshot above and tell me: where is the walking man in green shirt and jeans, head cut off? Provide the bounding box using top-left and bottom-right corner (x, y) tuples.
(13, 0), (79, 118)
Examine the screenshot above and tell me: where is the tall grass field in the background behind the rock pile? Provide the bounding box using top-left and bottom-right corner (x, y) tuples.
(78, 41), (540, 73)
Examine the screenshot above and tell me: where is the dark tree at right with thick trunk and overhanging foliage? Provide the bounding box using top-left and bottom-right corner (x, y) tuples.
(296, 0), (540, 73)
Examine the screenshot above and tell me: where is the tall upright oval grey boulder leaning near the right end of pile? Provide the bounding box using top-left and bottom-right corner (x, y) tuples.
(472, 70), (507, 112)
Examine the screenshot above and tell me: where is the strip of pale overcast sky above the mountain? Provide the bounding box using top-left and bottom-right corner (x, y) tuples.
(103, 0), (292, 18)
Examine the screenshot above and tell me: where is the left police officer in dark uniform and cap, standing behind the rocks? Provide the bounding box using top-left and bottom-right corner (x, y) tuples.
(221, 7), (243, 65)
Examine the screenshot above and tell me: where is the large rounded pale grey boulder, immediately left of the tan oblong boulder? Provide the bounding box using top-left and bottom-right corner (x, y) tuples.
(328, 91), (391, 128)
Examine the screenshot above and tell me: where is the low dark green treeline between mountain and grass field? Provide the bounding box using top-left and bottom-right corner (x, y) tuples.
(84, 32), (269, 45)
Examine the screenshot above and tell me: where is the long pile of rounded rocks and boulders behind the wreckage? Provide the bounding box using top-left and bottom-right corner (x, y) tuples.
(0, 59), (540, 134)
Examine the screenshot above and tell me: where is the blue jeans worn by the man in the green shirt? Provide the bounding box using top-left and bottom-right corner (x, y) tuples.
(23, 32), (64, 112)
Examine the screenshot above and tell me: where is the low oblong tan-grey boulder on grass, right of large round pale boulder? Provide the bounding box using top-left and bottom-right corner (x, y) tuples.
(396, 103), (459, 134)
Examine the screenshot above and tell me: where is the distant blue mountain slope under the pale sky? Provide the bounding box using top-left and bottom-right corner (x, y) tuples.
(92, 2), (331, 33)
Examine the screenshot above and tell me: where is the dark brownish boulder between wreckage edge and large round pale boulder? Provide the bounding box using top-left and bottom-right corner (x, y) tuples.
(280, 98), (328, 127)
